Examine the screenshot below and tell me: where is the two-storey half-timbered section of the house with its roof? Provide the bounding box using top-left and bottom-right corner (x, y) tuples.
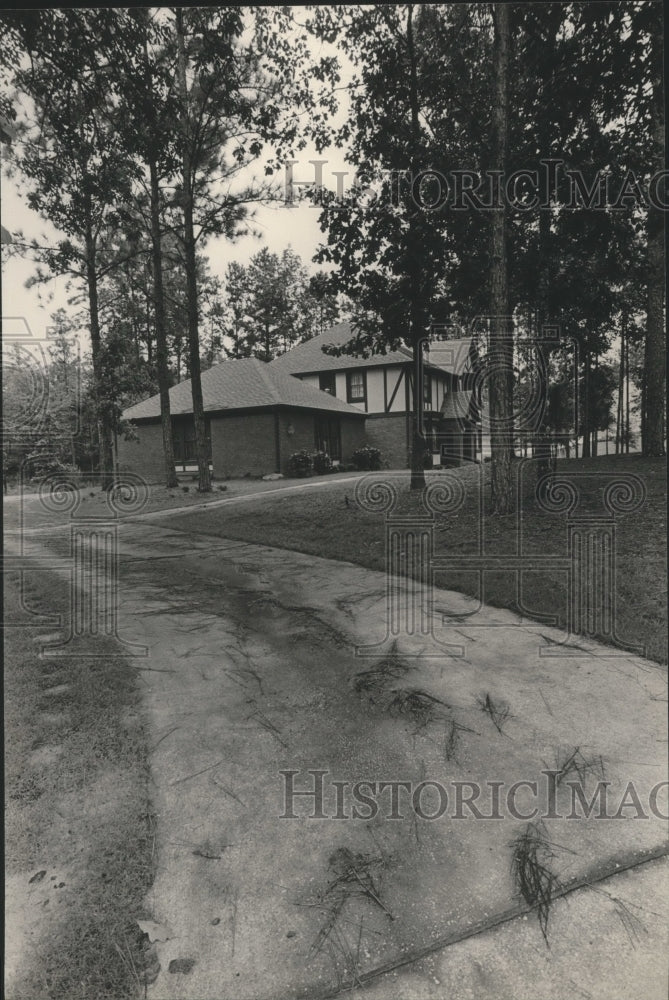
(269, 323), (481, 468)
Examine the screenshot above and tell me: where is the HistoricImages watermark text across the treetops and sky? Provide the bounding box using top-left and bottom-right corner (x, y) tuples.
(284, 158), (669, 212)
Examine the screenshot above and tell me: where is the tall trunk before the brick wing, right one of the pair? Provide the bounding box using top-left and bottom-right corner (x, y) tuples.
(175, 7), (211, 493)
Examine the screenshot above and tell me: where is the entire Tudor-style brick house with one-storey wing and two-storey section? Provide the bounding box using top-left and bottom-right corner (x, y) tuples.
(117, 323), (481, 481)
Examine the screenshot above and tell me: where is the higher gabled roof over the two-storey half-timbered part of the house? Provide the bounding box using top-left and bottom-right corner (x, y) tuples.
(270, 322), (476, 375)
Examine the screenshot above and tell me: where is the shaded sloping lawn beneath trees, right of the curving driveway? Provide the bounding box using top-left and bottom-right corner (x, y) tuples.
(163, 455), (667, 663)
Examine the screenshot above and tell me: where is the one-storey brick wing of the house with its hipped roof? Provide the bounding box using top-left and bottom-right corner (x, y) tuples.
(117, 358), (365, 482)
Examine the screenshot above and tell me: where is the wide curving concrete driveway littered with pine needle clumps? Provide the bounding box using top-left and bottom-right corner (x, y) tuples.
(11, 516), (669, 1000)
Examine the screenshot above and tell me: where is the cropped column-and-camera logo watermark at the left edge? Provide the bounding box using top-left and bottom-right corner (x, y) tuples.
(2, 317), (149, 658)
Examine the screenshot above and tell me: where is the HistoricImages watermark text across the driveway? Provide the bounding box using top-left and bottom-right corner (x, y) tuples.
(278, 768), (669, 822)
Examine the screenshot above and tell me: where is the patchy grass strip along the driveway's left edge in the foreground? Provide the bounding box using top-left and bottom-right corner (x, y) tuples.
(4, 571), (153, 1000)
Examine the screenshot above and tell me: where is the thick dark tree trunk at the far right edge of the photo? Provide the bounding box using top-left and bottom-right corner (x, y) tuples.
(644, 13), (666, 457)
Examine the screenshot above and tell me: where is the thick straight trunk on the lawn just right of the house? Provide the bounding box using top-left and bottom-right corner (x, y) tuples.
(489, 3), (514, 514)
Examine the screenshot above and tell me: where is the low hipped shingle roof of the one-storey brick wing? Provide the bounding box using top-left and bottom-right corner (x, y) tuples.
(123, 358), (364, 420)
